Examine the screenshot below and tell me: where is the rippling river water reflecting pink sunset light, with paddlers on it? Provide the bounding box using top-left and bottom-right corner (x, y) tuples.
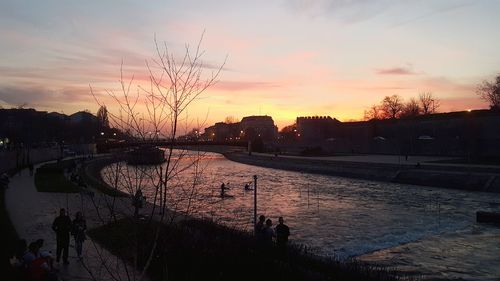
(103, 153), (500, 280)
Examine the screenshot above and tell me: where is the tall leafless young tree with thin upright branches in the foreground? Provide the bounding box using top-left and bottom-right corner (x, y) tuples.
(90, 35), (225, 280)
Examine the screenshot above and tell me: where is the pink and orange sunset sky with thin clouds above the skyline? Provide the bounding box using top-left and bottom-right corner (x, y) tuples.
(0, 0), (500, 128)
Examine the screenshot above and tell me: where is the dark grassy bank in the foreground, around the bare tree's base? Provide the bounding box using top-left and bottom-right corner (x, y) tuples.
(88, 219), (411, 281)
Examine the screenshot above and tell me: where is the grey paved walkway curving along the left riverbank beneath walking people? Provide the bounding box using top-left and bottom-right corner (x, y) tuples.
(6, 164), (150, 281)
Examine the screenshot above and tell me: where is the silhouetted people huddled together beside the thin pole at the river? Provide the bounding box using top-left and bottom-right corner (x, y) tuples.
(255, 215), (290, 250)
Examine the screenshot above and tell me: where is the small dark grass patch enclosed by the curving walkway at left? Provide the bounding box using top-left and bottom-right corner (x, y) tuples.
(35, 160), (80, 193)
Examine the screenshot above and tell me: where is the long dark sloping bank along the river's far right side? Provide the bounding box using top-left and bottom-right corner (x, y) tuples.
(223, 152), (500, 193)
